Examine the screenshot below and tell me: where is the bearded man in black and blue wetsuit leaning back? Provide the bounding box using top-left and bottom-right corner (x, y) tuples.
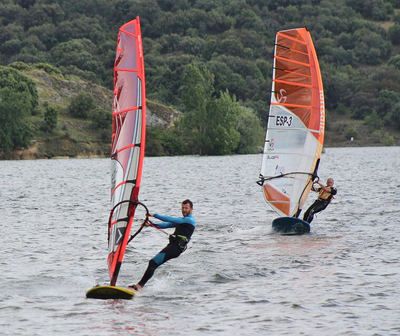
(129, 199), (196, 290)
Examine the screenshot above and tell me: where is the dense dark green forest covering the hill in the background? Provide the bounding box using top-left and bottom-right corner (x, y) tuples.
(0, 0), (400, 152)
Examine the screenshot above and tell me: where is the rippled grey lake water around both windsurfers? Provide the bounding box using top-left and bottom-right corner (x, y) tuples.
(0, 147), (400, 336)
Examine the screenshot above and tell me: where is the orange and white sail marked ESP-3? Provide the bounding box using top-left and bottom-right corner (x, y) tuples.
(260, 28), (325, 216)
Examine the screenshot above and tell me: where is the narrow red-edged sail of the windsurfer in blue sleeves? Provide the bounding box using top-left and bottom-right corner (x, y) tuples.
(107, 17), (146, 286)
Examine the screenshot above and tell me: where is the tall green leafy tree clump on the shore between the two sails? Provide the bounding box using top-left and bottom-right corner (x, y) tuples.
(181, 64), (253, 155)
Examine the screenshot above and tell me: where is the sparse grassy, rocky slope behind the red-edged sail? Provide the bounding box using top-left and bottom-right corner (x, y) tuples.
(2, 63), (179, 159)
